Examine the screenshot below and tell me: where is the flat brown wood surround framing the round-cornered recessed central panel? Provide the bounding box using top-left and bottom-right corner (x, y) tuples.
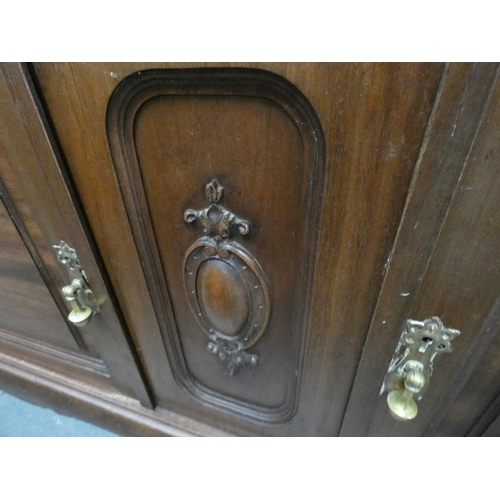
(33, 63), (443, 435)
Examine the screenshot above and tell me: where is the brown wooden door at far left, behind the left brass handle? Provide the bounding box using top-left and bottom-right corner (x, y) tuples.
(0, 64), (151, 407)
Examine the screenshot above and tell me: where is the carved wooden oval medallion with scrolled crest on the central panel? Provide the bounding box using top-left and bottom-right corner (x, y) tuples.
(184, 179), (271, 375)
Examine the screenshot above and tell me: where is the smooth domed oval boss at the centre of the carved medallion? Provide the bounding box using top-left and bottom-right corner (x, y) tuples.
(196, 259), (250, 336)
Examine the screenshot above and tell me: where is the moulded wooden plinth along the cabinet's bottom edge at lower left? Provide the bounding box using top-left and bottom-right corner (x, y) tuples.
(0, 332), (227, 436)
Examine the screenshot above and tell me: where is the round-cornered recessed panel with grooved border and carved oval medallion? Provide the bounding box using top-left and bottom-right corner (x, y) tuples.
(107, 69), (326, 422)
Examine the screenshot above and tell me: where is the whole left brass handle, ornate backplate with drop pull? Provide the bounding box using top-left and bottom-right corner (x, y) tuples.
(53, 241), (100, 327)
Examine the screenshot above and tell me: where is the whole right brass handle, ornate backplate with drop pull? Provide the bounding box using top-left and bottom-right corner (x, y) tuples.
(381, 316), (460, 420)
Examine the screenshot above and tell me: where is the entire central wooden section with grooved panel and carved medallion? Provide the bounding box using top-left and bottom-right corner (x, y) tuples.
(30, 63), (443, 436)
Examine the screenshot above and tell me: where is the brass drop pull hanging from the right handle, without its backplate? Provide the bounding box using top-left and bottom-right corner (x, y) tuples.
(387, 361), (425, 420)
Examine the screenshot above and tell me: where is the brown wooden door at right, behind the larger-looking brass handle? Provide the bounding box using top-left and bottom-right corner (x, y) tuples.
(342, 64), (500, 436)
